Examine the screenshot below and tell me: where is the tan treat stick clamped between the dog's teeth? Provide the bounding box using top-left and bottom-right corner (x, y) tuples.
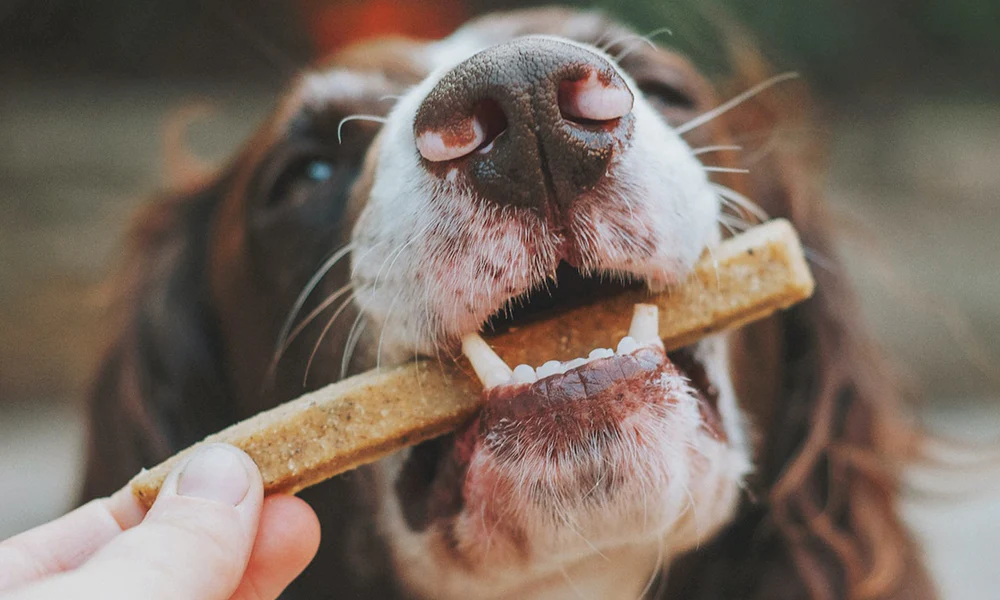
(131, 220), (813, 507)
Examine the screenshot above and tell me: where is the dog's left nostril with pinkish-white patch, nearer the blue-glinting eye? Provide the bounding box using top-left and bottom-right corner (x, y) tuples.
(417, 100), (507, 162)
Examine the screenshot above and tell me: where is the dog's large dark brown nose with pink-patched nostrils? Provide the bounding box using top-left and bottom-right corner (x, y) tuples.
(413, 38), (634, 212)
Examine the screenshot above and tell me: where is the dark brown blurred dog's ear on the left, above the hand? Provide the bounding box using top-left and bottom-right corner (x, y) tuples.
(83, 175), (233, 499)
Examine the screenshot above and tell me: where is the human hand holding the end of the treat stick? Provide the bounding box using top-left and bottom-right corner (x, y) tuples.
(0, 444), (319, 600)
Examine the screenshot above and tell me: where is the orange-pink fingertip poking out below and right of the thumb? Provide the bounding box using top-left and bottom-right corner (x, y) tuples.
(232, 496), (319, 600)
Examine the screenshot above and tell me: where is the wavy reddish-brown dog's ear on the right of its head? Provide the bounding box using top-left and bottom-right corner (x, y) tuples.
(663, 50), (936, 600)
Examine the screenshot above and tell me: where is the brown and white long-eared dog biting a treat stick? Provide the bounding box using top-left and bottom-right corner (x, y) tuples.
(84, 8), (935, 600)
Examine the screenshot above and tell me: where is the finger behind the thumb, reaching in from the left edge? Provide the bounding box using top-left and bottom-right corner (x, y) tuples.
(0, 489), (145, 591)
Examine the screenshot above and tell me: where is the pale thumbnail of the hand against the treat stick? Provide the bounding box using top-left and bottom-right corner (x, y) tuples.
(177, 445), (250, 506)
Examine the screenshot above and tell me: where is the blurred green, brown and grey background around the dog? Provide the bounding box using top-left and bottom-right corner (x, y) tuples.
(0, 0), (1000, 600)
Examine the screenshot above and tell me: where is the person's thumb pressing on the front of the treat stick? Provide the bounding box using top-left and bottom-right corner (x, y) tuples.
(7, 444), (263, 600)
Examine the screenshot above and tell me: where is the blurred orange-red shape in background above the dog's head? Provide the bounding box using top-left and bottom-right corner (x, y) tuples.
(299, 0), (467, 55)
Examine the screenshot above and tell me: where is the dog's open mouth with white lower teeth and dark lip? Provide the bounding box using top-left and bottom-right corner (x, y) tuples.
(396, 266), (725, 529)
